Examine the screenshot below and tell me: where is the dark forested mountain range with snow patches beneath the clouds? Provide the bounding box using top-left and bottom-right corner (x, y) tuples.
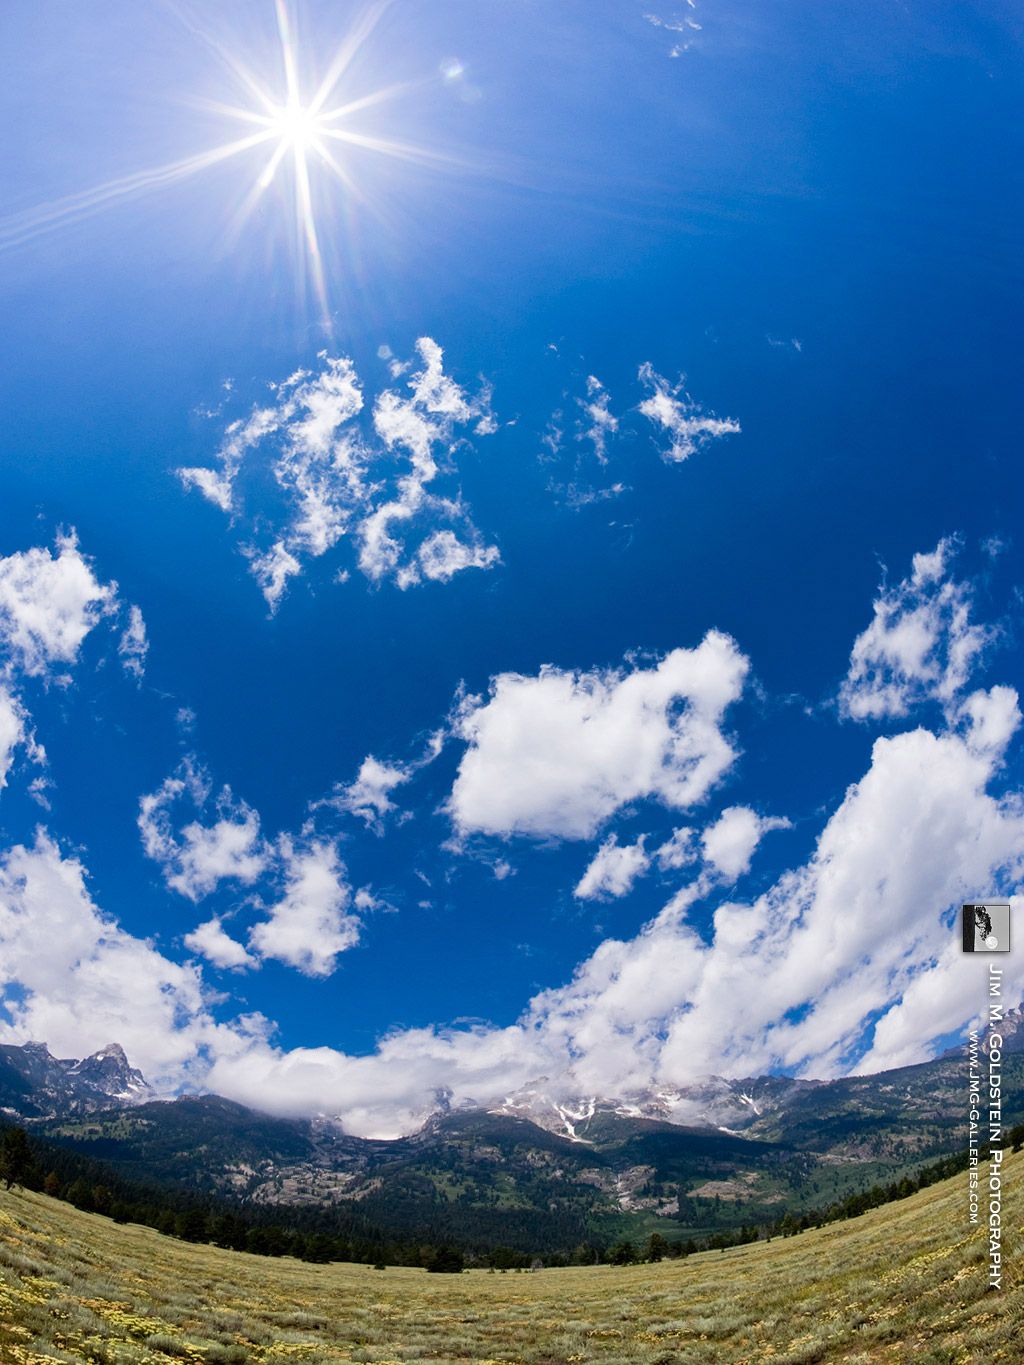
(0, 1010), (1024, 1248)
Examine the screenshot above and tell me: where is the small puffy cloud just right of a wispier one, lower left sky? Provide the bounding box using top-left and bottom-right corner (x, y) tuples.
(248, 837), (360, 976)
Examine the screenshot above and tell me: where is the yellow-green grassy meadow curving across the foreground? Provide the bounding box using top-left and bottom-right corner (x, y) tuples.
(0, 1156), (1024, 1365)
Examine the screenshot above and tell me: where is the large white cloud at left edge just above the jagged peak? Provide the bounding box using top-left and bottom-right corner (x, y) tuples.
(0, 831), (265, 1088)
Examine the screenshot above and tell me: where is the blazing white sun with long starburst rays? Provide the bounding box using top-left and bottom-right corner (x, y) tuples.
(0, 0), (439, 326)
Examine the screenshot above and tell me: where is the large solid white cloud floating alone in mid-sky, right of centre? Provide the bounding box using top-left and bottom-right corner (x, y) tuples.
(448, 631), (748, 838)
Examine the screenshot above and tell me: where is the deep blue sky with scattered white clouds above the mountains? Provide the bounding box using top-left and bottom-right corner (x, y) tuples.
(0, 0), (1024, 1133)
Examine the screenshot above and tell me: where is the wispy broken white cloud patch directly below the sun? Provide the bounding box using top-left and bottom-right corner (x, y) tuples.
(179, 337), (500, 612)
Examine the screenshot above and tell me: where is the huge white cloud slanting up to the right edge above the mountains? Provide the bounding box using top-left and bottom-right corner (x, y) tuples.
(527, 704), (1024, 1095)
